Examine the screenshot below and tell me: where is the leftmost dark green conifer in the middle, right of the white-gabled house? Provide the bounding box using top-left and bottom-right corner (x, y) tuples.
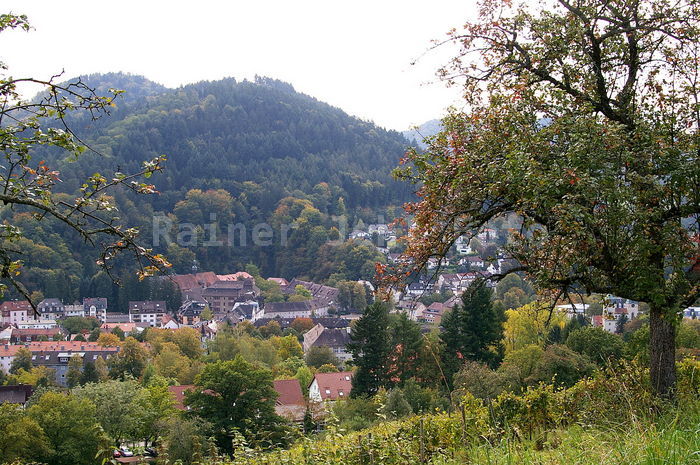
(347, 302), (390, 397)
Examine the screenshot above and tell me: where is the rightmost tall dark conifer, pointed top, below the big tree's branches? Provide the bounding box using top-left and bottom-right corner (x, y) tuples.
(440, 281), (505, 381)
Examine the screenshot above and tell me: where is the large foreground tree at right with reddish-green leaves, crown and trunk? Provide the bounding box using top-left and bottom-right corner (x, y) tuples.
(388, 0), (700, 395)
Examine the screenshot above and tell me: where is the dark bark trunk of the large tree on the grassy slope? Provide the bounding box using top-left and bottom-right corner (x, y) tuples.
(649, 305), (676, 398)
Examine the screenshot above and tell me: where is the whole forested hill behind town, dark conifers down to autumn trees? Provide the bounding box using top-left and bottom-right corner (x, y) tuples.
(2, 73), (411, 300)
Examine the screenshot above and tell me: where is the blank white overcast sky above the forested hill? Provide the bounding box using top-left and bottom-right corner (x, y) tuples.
(0, 0), (475, 130)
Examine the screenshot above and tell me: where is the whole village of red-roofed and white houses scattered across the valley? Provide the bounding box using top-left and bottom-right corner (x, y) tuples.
(0, 221), (700, 399)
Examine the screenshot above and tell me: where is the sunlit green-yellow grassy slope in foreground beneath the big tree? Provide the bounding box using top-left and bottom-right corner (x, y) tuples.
(207, 365), (700, 465)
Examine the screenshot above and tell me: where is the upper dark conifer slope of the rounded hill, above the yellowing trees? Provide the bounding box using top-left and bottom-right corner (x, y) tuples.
(52, 74), (408, 209)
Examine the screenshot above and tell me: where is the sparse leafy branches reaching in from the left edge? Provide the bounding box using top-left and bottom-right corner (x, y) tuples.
(0, 14), (168, 305)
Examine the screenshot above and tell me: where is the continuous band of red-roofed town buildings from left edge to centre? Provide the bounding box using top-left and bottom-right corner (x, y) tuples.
(0, 272), (359, 386)
